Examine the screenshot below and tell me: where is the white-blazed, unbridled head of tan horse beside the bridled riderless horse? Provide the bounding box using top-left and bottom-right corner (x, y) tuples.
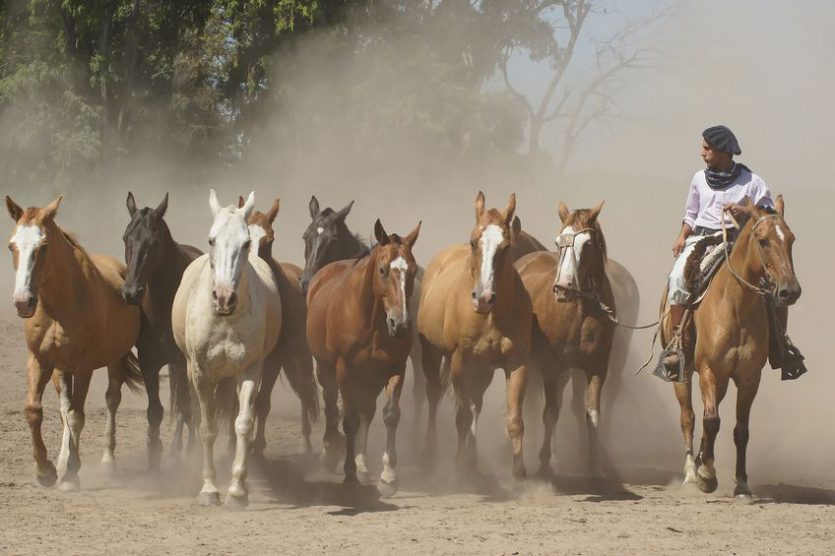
(470, 191), (516, 313)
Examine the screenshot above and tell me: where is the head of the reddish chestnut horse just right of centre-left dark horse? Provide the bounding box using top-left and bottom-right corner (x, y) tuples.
(371, 219), (421, 336)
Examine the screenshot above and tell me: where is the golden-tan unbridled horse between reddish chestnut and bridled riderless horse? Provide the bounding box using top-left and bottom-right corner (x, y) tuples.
(418, 192), (532, 478)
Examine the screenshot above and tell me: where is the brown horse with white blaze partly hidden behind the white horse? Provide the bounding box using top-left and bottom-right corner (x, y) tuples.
(238, 197), (319, 456)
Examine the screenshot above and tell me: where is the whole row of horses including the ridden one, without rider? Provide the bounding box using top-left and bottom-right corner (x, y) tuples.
(6, 190), (800, 508)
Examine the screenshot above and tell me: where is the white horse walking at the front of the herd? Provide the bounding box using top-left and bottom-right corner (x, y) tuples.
(171, 189), (281, 508)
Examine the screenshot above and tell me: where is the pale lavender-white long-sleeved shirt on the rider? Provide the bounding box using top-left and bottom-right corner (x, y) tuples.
(683, 170), (774, 230)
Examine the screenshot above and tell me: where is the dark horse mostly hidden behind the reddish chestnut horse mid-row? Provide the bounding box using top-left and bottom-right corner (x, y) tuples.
(301, 195), (426, 430)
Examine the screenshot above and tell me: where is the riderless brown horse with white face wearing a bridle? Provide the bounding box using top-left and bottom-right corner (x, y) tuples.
(516, 203), (615, 476)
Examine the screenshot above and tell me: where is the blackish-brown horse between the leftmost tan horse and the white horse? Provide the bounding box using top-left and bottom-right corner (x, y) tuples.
(122, 192), (202, 469)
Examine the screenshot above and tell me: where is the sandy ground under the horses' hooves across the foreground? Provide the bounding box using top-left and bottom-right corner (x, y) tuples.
(0, 304), (835, 554)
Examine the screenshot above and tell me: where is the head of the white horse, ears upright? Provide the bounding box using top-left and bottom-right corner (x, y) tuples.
(209, 189), (255, 316)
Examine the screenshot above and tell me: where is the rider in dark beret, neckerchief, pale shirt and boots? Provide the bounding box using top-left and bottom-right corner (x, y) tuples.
(655, 125), (806, 381)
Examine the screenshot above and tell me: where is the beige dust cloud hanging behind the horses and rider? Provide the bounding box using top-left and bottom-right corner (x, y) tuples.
(0, 0), (835, 496)
